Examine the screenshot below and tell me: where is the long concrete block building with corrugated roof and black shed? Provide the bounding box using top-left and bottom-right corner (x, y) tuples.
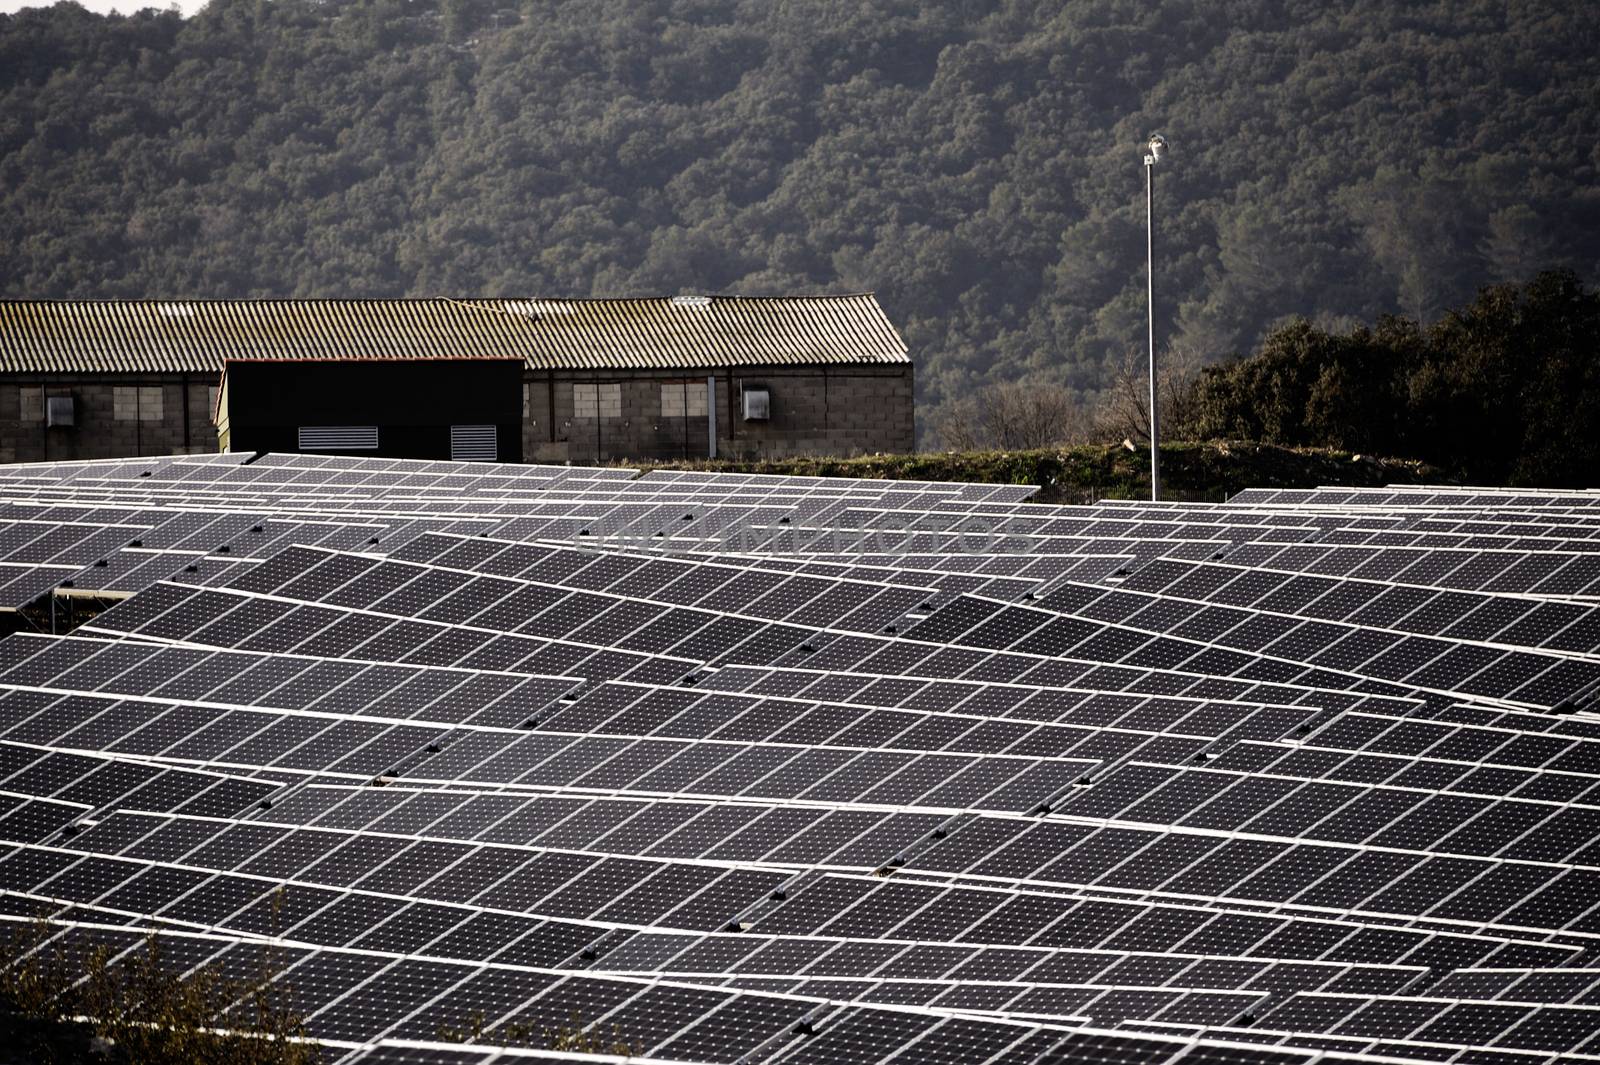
(0, 294), (915, 462)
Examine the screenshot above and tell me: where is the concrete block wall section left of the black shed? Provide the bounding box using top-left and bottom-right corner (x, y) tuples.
(0, 374), (216, 462)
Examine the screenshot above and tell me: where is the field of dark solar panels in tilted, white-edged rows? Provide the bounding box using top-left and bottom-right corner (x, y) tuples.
(0, 456), (1600, 1065)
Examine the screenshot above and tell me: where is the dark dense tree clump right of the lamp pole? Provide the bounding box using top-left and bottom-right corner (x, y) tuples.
(1181, 270), (1600, 486)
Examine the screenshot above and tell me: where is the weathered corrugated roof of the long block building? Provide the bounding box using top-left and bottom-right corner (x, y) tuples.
(0, 294), (910, 373)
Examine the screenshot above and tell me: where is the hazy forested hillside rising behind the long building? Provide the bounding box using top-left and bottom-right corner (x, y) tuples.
(0, 0), (1600, 431)
